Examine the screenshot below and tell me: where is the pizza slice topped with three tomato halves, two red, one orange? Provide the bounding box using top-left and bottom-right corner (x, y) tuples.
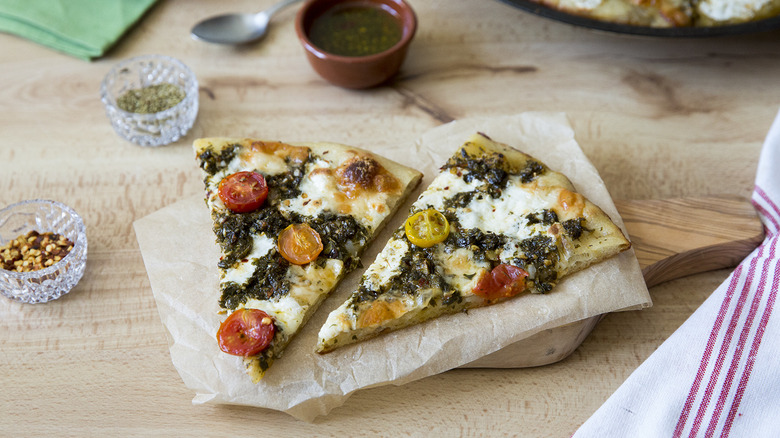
(193, 138), (421, 382)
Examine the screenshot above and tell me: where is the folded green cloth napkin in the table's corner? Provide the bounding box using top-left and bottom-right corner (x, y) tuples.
(0, 0), (157, 60)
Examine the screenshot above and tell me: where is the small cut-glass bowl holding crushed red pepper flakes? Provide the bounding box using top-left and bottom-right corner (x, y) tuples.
(0, 199), (87, 303)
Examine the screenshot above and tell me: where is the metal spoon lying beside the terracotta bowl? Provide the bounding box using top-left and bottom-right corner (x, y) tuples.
(190, 0), (301, 44)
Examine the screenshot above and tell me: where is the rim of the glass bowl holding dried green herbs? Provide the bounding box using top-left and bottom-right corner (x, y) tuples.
(100, 55), (199, 122)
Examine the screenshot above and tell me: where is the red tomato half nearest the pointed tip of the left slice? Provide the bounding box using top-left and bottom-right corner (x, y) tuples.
(217, 309), (276, 356)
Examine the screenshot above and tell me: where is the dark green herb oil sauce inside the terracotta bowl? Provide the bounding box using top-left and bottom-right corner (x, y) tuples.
(309, 6), (402, 56)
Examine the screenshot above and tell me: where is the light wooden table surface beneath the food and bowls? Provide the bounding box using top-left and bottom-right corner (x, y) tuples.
(0, 0), (780, 437)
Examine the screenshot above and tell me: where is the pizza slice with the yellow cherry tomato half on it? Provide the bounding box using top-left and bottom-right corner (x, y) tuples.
(317, 134), (630, 353)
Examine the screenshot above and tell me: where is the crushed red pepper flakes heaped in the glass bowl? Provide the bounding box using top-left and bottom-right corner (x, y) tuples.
(0, 230), (73, 272)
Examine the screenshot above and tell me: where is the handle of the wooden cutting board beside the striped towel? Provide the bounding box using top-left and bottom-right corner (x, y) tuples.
(615, 196), (764, 287)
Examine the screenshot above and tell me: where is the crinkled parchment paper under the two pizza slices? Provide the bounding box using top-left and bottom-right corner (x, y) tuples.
(134, 113), (650, 421)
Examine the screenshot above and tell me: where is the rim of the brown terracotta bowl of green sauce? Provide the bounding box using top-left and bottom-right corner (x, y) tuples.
(295, 0), (417, 64)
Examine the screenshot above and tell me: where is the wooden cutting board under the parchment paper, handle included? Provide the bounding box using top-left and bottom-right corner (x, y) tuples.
(463, 196), (764, 368)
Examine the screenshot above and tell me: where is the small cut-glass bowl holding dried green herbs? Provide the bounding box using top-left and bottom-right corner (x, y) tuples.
(100, 55), (198, 146)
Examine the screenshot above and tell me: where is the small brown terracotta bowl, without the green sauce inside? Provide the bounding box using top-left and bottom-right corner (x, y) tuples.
(295, 0), (417, 89)
